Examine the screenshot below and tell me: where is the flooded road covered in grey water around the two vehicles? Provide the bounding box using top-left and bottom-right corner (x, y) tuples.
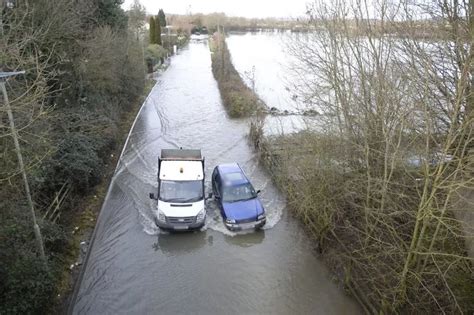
(72, 43), (359, 314)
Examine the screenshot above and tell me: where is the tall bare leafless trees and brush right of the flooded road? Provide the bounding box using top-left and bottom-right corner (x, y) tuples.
(252, 0), (474, 314)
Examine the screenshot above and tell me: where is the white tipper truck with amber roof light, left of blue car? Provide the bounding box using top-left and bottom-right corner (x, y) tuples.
(150, 149), (206, 230)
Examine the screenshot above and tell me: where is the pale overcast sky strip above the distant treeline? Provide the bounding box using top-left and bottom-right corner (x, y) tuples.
(123, 0), (311, 18)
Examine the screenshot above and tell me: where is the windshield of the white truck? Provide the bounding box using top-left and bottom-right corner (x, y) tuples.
(160, 180), (204, 202)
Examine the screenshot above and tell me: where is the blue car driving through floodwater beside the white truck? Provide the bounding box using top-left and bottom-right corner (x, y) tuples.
(212, 163), (266, 231)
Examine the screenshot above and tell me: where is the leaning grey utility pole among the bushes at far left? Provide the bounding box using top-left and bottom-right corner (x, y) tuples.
(0, 71), (47, 267)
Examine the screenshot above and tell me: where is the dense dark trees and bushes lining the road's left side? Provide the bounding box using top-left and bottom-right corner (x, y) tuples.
(0, 0), (145, 314)
